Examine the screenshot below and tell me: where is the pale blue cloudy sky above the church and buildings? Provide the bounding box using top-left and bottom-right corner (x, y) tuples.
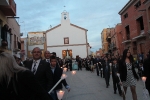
(15, 0), (129, 51)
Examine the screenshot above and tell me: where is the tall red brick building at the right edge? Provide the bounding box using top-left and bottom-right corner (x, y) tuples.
(119, 0), (150, 57)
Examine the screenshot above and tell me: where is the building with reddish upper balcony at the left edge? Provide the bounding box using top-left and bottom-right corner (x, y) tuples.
(0, 0), (23, 56)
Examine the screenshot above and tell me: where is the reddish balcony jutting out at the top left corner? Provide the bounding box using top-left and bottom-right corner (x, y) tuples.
(0, 0), (16, 16)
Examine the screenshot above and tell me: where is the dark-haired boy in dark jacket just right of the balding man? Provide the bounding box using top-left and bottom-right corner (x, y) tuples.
(50, 56), (70, 100)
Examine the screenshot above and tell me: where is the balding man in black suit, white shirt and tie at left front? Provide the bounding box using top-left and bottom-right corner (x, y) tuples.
(25, 47), (53, 92)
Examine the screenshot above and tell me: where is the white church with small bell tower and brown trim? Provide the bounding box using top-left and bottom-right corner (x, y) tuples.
(46, 11), (89, 58)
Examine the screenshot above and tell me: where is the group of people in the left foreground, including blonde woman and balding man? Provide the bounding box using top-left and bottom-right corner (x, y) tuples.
(0, 47), (70, 100)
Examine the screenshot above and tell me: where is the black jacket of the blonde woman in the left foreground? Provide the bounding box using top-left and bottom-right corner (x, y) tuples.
(0, 70), (52, 100)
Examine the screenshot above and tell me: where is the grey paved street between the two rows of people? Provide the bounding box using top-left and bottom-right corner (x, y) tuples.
(63, 69), (149, 100)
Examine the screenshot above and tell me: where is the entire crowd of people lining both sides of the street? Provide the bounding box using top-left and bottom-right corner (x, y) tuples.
(0, 41), (150, 100)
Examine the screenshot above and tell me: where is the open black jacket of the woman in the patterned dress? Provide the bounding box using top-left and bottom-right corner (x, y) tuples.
(119, 60), (139, 81)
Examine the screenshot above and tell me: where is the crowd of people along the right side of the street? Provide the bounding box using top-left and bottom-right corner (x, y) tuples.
(72, 49), (150, 100)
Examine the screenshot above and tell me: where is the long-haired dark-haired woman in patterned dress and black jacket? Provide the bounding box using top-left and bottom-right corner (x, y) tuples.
(119, 49), (139, 100)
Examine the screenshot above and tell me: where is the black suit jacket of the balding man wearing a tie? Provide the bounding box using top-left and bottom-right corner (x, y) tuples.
(25, 60), (53, 92)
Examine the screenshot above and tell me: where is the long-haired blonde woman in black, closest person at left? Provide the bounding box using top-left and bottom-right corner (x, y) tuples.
(0, 52), (51, 100)
